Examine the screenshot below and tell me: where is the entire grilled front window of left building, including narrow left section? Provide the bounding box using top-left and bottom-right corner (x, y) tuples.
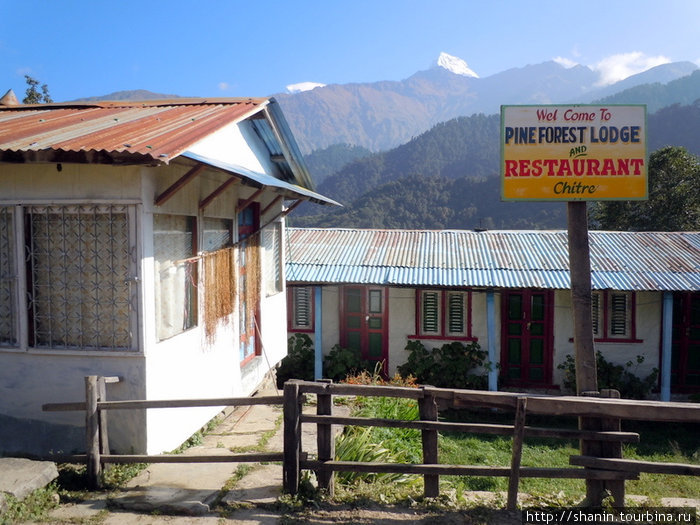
(0, 205), (136, 350)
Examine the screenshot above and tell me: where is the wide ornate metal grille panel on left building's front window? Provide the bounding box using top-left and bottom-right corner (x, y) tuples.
(25, 205), (133, 350)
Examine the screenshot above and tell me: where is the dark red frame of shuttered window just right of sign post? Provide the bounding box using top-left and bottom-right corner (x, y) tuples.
(591, 290), (644, 343)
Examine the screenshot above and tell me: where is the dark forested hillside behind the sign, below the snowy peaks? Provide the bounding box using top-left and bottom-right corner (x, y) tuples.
(290, 100), (700, 229)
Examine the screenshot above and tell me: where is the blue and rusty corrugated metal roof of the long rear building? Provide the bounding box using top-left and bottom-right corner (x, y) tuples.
(286, 228), (700, 291)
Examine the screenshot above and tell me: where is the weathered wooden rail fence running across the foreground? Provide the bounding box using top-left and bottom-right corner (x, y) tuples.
(43, 376), (700, 509)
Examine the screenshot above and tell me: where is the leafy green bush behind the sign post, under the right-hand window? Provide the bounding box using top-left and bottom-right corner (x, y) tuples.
(557, 351), (659, 399)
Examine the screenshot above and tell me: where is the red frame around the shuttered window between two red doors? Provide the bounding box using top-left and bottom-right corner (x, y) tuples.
(409, 288), (478, 341)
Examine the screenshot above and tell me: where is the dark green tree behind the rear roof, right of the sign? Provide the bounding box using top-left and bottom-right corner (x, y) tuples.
(590, 146), (700, 231)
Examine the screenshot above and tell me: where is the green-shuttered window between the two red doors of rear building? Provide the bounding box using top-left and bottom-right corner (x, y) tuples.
(415, 290), (472, 339)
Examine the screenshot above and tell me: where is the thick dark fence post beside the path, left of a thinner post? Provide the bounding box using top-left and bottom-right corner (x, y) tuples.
(282, 380), (301, 495)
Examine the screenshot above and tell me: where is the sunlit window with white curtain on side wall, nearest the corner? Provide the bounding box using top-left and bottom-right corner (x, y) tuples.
(153, 215), (197, 341)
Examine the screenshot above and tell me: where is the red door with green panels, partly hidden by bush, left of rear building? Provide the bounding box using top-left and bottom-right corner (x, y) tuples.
(340, 286), (389, 374)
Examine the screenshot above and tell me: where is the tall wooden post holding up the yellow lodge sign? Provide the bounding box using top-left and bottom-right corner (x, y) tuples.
(567, 201), (603, 506)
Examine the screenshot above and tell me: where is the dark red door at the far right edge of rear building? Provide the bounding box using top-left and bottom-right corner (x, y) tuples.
(671, 293), (700, 392)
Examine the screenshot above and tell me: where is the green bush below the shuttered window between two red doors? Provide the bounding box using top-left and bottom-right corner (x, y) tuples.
(397, 341), (487, 389)
